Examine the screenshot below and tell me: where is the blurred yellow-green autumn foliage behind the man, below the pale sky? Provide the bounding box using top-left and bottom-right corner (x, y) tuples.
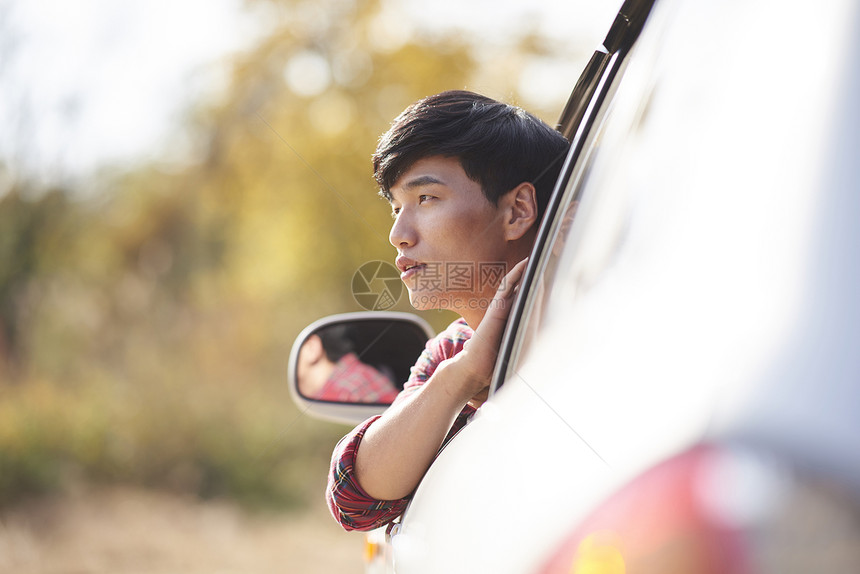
(0, 0), (576, 506)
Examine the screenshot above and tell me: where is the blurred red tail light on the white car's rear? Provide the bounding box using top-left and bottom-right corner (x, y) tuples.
(540, 446), (752, 574)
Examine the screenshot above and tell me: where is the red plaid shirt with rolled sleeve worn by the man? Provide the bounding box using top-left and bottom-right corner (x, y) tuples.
(326, 319), (475, 530)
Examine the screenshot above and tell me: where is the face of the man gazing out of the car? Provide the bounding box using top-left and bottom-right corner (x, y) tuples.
(389, 156), (510, 324)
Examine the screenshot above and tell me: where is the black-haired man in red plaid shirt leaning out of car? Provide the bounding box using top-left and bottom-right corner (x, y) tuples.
(327, 91), (568, 530)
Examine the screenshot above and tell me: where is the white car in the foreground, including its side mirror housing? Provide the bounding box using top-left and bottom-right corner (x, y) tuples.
(291, 0), (860, 574)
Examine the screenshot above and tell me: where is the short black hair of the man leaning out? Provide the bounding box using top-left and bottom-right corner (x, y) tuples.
(373, 90), (570, 216)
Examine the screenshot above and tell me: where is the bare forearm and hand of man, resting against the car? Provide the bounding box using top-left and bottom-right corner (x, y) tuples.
(355, 260), (526, 500)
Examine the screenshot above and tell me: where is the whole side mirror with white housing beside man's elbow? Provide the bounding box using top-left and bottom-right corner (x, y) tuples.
(289, 311), (434, 424)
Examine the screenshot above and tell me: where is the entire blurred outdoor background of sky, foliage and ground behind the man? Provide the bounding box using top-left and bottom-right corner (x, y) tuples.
(0, 0), (620, 572)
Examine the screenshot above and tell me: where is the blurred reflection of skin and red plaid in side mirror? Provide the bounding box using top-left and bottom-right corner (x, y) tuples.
(296, 330), (398, 403)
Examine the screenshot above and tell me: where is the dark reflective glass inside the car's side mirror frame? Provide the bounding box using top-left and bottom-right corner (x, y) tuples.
(294, 320), (427, 404)
